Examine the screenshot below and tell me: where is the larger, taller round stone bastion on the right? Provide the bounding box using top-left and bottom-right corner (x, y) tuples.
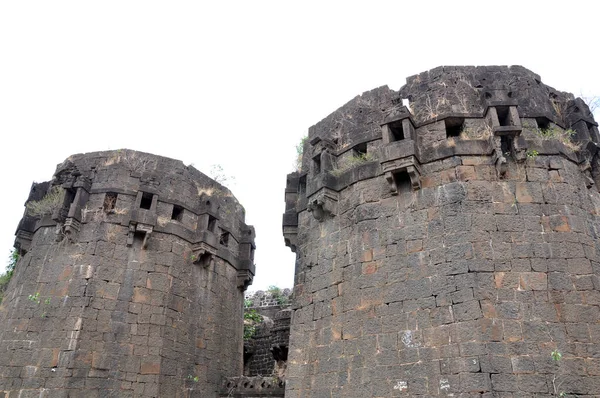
(283, 66), (600, 398)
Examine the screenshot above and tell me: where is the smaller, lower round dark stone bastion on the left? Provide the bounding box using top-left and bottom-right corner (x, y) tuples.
(0, 150), (254, 397)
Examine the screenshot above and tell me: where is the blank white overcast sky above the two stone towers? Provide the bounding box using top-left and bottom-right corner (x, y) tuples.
(0, 0), (600, 290)
